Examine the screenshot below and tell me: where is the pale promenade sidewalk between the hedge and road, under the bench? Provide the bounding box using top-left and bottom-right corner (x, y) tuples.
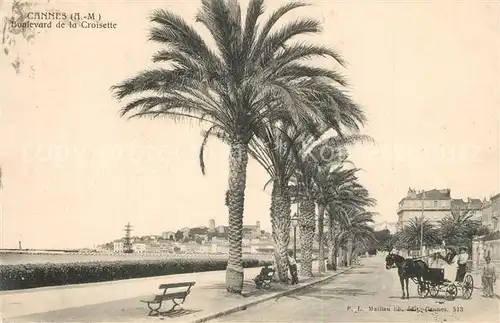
(0, 266), (348, 322)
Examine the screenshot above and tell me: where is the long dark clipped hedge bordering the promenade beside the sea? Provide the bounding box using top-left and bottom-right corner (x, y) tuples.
(0, 259), (270, 290)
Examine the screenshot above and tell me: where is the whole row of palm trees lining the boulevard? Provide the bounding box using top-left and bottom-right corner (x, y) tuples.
(112, 0), (375, 293)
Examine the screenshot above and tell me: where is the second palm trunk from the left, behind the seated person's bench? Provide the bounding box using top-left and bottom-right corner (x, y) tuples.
(271, 182), (291, 283)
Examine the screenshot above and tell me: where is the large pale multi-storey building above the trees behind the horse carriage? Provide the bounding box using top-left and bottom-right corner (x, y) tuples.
(396, 188), (482, 231)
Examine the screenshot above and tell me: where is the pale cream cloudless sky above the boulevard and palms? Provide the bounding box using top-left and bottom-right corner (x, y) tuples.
(0, 0), (500, 248)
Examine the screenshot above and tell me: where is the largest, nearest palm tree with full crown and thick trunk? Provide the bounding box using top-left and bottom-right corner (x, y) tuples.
(112, 0), (354, 293)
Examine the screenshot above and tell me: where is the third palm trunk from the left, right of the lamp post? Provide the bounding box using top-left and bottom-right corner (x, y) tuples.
(299, 198), (316, 277)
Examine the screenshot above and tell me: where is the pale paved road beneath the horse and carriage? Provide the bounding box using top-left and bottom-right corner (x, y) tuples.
(215, 257), (500, 322)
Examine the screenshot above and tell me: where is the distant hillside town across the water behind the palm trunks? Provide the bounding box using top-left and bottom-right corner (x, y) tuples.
(96, 219), (273, 253)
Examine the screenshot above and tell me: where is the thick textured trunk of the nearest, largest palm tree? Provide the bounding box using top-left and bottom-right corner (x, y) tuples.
(226, 141), (248, 294)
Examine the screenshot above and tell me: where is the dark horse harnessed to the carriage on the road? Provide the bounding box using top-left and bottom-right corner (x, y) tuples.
(385, 254), (429, 299)
